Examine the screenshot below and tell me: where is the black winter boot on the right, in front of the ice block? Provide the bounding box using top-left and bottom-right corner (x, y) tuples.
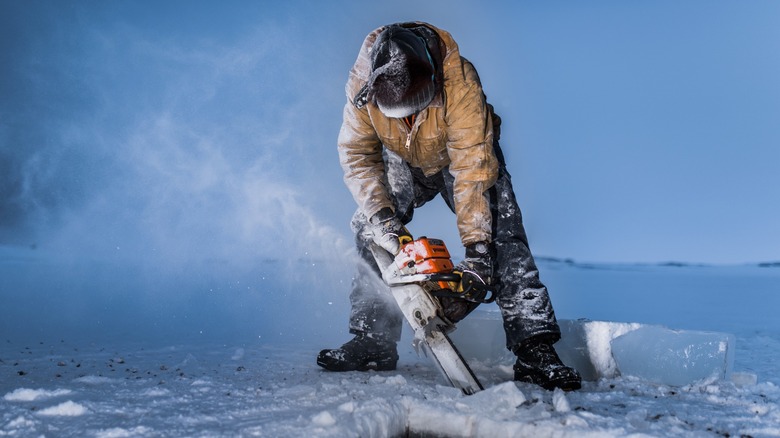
(513, 336), (582, 391)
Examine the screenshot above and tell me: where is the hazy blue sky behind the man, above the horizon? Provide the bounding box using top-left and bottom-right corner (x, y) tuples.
(0, 0), (780, 263)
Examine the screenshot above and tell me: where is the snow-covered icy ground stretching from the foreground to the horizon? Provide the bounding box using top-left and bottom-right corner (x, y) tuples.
(0, 248), (780, 437)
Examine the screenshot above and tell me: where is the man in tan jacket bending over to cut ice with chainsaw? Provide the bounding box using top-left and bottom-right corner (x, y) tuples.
(317, 22), (581, 390)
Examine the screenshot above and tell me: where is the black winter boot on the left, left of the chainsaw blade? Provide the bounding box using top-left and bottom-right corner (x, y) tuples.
(317, 333), (398, 371)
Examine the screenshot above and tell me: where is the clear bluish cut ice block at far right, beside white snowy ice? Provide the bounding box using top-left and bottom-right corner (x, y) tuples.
(612, 326), (734, 386)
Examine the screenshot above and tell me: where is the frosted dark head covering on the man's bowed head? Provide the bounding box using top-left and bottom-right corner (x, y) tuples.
(368, 25), (436, 118)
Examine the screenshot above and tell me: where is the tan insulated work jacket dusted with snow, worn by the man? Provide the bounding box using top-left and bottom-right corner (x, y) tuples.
(338, 23), (498, 245)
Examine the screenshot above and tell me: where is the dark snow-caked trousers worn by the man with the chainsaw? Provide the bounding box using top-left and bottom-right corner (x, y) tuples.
(349, 142), (560, 350)
